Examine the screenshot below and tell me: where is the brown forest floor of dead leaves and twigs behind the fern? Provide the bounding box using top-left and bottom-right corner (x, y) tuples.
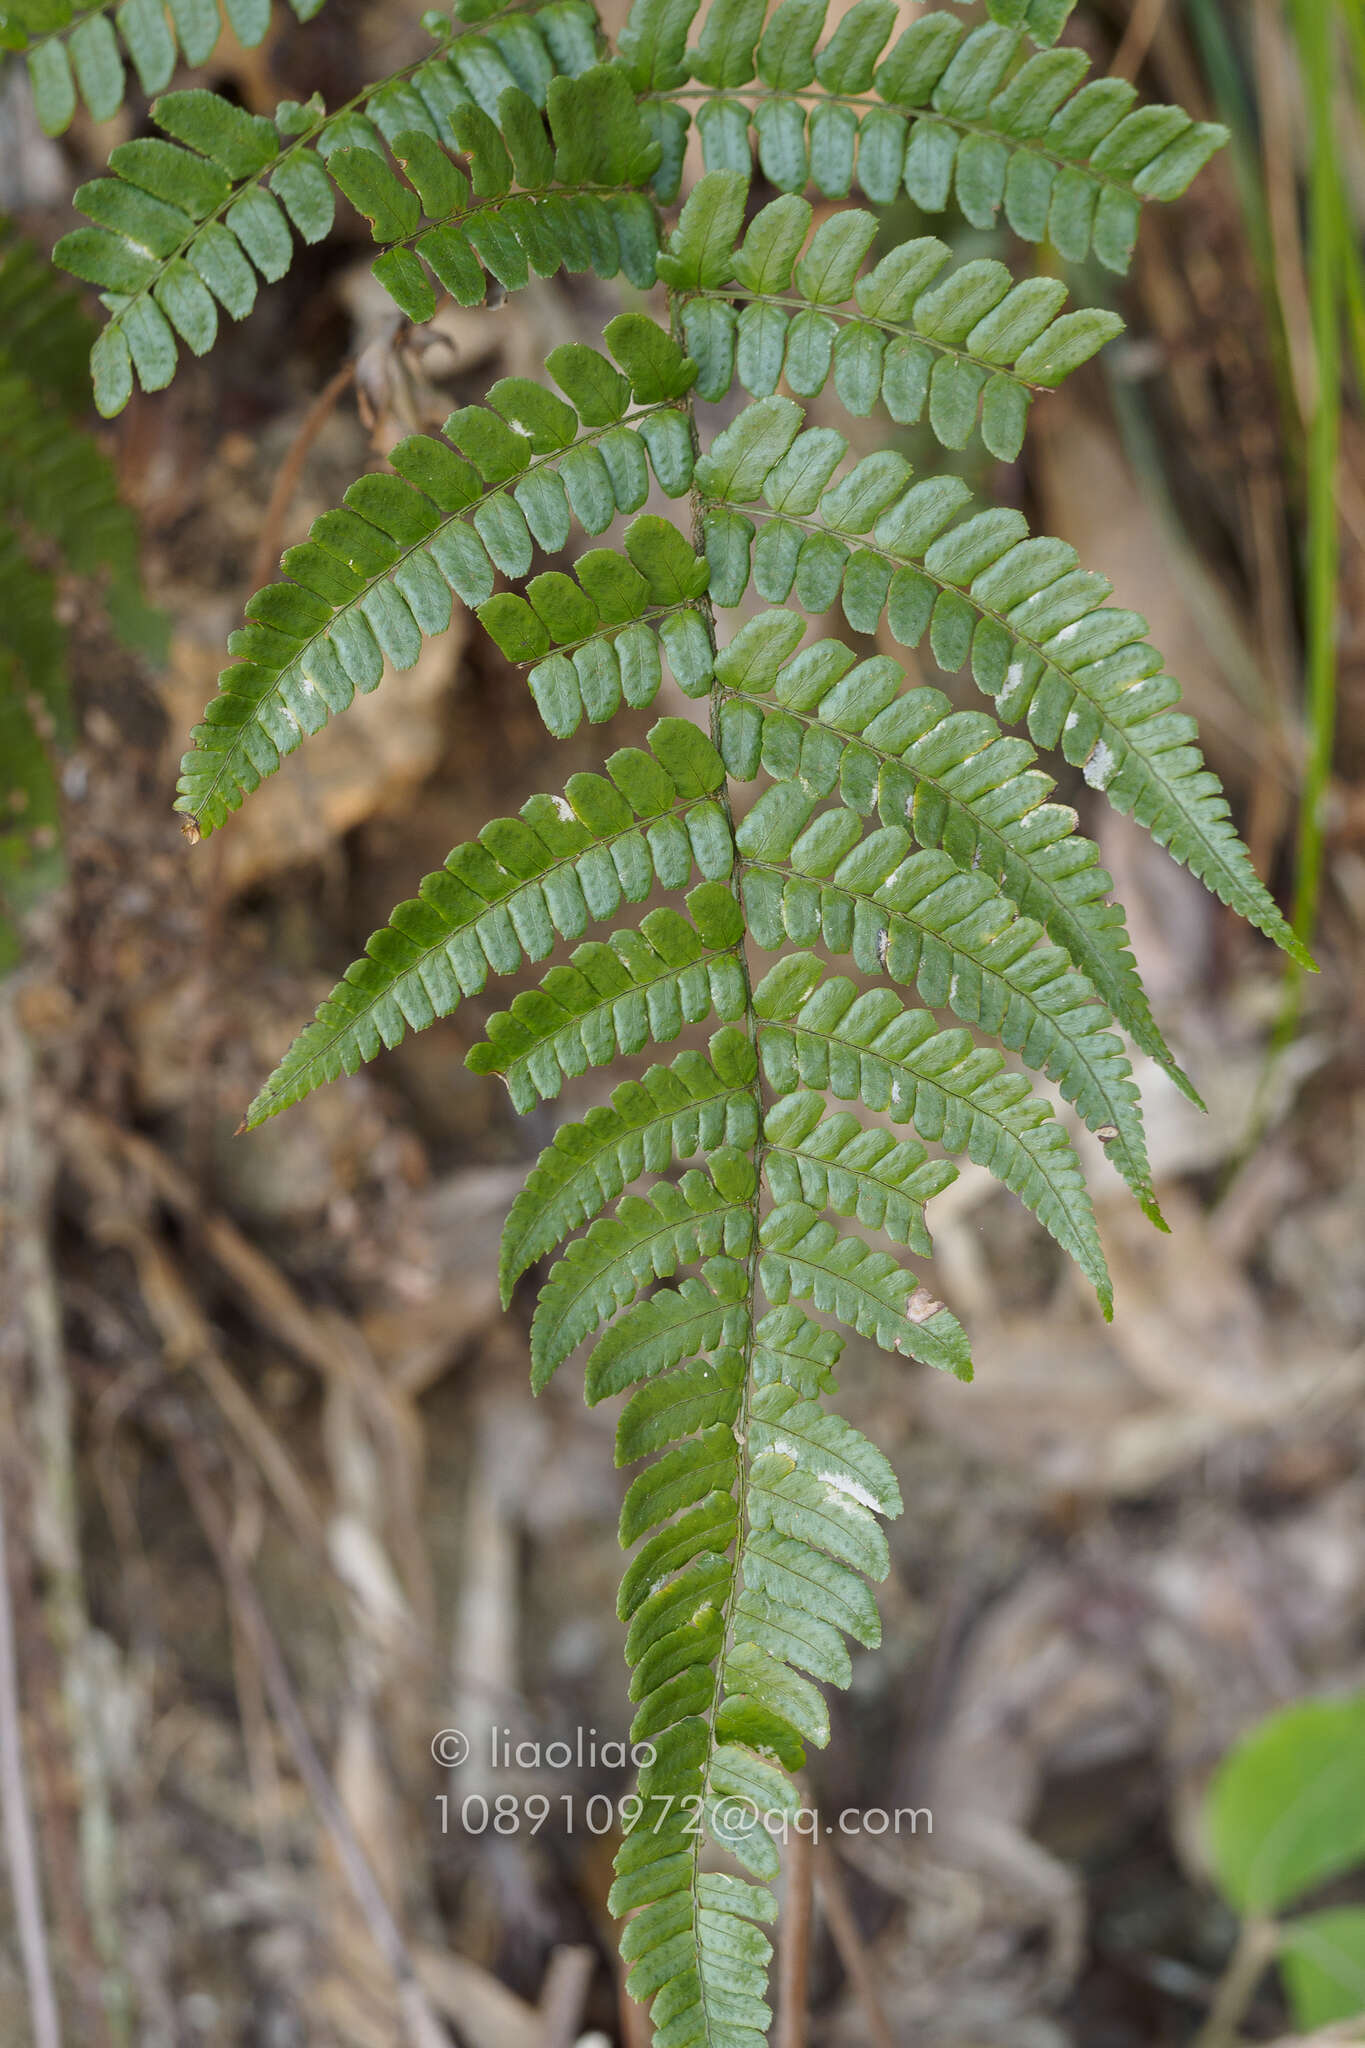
(0, 0), (1365, 2048)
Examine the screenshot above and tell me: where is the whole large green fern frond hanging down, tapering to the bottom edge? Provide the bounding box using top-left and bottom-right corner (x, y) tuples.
(61, 0), (1297, 2048)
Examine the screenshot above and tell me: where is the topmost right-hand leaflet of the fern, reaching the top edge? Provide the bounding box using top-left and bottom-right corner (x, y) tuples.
(618, 0), (1228, 272)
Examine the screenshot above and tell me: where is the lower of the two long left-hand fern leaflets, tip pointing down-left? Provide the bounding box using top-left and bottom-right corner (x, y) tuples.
(246, 719), (733, 1130)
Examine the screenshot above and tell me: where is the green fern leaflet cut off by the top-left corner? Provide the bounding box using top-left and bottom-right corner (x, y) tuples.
(0, 0), (323, 135)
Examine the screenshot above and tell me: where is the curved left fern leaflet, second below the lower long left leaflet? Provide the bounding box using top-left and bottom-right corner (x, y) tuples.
(497, 1024), (759, 1305)
